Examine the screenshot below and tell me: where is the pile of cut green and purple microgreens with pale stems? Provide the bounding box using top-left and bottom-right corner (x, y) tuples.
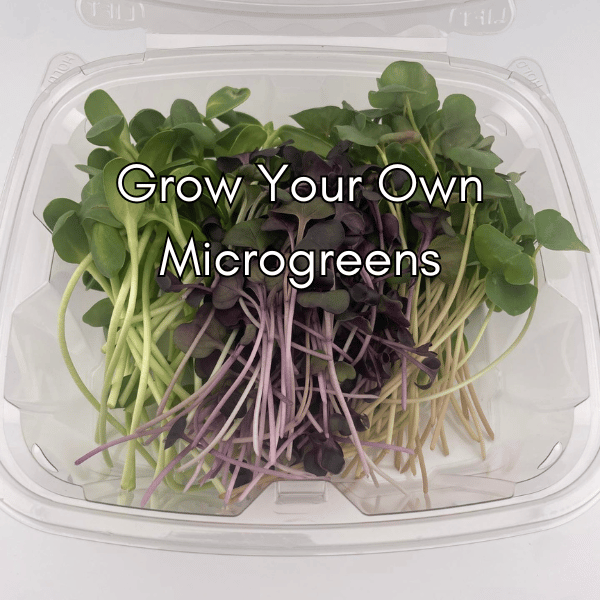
(44, 61), (587, 504)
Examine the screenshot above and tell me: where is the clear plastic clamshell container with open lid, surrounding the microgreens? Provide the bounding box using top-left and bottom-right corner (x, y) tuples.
(0, 0), (600, 555)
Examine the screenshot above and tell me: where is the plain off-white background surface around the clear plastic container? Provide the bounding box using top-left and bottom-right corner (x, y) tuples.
(0, 0), (600, 600)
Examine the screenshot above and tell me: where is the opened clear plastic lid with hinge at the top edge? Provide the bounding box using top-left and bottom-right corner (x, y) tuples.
(77, 0), (515, 47)
